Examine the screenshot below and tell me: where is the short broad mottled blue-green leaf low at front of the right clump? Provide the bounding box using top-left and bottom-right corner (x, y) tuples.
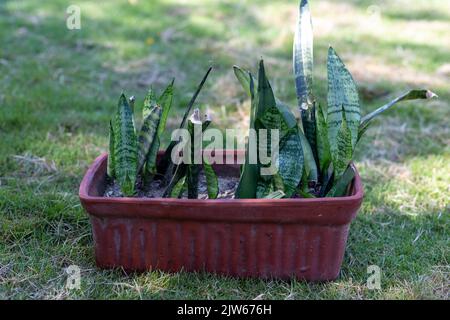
(278, 131), (304, 198)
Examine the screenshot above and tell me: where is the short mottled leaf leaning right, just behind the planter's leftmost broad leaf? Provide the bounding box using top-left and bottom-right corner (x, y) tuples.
(138, 106), (162, 173)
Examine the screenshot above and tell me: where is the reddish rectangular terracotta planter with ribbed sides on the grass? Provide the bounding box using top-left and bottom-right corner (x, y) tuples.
(80, 152), (363, 281)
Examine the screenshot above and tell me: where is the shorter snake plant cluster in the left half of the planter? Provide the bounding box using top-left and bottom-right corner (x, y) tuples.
(108, 68), (218, 198)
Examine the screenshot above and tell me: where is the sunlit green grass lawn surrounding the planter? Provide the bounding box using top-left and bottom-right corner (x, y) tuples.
(0, 0), (450, 299)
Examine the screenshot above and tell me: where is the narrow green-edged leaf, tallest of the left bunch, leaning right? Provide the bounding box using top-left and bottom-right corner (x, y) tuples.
(144, 80), (174, 183)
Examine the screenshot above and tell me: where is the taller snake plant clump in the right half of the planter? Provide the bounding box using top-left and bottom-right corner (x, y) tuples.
(234, 0), (436, 198)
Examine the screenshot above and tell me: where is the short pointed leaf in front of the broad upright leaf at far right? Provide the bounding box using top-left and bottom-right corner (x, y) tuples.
(331, 113), (353, 181)
